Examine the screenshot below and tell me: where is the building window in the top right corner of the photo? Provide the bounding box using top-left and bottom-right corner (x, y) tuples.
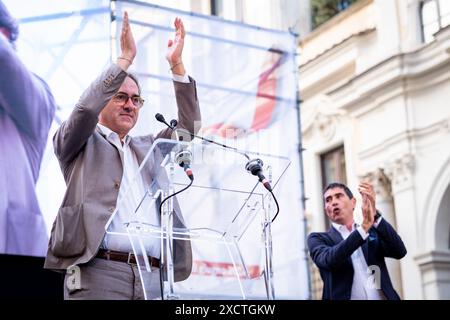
(420, 0), (450, 42)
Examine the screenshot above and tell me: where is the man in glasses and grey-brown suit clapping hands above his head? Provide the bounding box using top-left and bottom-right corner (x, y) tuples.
(45, 13), (200, 299)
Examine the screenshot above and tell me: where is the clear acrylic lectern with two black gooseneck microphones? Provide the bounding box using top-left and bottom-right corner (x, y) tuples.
(106, 139), (290, 299)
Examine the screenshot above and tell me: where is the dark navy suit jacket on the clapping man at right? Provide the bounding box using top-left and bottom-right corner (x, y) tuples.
(308, 218), (406, 300)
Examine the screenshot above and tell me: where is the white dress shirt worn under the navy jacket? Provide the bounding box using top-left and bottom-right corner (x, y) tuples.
(332, 217), (385, 300)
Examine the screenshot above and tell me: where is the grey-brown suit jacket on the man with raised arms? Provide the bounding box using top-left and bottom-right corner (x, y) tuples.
(44, 64), (200, 281)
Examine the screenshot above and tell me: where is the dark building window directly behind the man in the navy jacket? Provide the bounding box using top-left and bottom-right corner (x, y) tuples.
(320, 146), (347, 229)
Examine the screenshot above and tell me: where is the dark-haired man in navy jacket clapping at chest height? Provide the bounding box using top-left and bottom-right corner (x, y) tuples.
(308, 183), (406, 300)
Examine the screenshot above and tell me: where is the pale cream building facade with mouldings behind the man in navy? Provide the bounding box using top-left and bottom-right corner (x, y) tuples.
(300, 0), (450, 299)
